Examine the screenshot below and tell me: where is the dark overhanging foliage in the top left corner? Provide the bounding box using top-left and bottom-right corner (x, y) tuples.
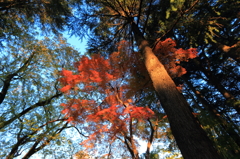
(0, 0), (82, 44)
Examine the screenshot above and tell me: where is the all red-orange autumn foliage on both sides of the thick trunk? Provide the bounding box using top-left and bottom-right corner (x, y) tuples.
(59, 39), (197, 154)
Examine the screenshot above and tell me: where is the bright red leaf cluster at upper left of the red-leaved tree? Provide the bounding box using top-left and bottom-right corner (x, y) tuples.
(60, 54), (119, 93)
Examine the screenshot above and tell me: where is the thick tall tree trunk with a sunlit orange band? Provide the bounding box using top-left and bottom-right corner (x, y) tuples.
(132, 22), (220, 159)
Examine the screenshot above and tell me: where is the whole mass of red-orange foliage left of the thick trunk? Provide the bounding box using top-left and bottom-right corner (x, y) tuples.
(59, 41), (154, 148)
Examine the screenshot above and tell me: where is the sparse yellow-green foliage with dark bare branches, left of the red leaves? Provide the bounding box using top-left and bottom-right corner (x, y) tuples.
(0, 32), (84, 158)
